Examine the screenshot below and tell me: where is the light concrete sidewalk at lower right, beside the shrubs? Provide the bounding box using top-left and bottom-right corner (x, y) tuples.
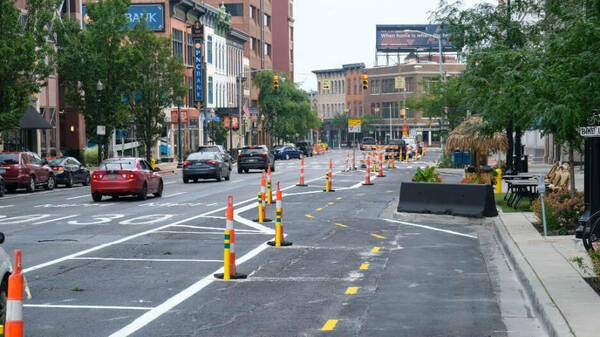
(495, 212), (600, 337)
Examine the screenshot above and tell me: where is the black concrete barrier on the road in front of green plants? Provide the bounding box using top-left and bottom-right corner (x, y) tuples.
(398, 182), (498, 218)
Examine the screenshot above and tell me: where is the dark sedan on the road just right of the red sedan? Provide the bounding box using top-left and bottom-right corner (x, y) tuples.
(183, 152), (231, 184)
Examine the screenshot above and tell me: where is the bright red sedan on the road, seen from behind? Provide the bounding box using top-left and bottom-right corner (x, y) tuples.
(92, 158), (163, 201)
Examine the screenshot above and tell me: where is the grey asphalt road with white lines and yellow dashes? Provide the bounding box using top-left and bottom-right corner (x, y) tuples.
(0, 151), (543, 337)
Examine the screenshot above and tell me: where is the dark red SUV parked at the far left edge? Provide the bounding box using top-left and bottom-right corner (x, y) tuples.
(0, 152), (56, 192)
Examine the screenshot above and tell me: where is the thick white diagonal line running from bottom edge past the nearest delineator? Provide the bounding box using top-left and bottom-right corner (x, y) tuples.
(110, 241), (269, 337)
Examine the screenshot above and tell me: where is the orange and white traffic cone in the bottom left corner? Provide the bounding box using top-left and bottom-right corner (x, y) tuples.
(5, 249), (23, 337)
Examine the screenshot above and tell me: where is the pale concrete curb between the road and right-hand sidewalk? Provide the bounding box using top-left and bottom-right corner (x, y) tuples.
(494, 211), (575, 337)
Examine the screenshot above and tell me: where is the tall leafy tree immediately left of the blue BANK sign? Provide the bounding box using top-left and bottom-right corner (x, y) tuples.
(58, 0), (135, 159)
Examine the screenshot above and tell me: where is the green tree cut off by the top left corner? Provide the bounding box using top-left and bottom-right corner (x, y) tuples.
(0, 0), (59, 131)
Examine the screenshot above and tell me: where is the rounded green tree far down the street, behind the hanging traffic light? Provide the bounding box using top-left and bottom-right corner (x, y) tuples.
(254, 71), (321, 142)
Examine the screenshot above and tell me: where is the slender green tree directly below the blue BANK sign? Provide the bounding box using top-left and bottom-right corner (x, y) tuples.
(126, 20), (186, 161)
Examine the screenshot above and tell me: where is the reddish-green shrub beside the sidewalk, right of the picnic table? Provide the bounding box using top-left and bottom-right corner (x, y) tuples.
(531, 190), (585, 234)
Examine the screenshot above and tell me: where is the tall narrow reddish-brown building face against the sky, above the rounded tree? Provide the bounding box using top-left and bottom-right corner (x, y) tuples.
(273, 0), (294, 81)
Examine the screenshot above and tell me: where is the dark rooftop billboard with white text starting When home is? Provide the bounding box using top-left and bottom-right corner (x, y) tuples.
(375, 25), (456, 53)
